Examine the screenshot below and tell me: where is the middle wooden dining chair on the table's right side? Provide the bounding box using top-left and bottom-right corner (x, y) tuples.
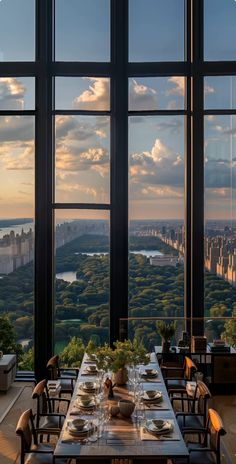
(172, 380), (211, 436)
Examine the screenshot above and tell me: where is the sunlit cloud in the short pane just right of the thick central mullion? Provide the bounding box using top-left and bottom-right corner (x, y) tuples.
(129, 79), (158, 110)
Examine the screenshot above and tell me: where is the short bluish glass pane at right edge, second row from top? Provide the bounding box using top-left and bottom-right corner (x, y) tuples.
(204, 76), (236, 110)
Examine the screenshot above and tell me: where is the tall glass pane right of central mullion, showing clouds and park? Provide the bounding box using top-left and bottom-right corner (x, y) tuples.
(129, 116), (185, 318)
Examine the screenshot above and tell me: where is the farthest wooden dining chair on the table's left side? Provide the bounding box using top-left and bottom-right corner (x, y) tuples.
(47, 355), (79, 395)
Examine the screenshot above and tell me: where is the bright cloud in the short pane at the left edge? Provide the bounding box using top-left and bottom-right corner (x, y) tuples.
(0, 77), (26, 110)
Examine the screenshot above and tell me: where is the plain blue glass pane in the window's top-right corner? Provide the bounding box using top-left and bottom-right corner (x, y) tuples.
(204, 0), (236, 61)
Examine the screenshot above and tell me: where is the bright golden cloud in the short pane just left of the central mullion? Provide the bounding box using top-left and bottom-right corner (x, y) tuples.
(73, 77), (110, 111)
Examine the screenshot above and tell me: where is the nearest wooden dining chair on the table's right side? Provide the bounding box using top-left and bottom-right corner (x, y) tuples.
(173, 409), (226, 464)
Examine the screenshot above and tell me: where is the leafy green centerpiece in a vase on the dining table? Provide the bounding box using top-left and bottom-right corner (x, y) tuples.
(89, 339), (149, 385)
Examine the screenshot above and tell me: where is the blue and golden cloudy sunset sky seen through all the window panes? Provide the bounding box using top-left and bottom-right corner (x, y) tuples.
(0, 0), (236, 220)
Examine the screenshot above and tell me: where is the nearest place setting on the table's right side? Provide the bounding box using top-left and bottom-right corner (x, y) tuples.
(140, 419), (180, 441)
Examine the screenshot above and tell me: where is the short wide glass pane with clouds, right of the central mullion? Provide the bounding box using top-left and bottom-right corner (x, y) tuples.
(129, 76), (185, 111)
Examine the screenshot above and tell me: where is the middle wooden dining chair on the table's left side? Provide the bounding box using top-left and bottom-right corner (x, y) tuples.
(32, 380), (70, 434)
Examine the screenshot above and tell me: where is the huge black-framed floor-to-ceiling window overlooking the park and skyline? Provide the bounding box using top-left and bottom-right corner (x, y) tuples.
(0, 0), (236, 376)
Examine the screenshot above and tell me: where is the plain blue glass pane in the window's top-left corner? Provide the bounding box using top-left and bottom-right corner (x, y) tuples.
(0, 0), (35, 61)
